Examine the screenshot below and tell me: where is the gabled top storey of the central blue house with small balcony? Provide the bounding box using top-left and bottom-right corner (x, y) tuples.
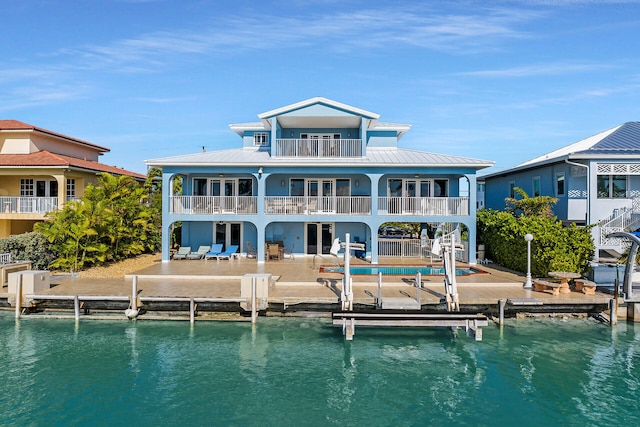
(230, 97), (410, 158)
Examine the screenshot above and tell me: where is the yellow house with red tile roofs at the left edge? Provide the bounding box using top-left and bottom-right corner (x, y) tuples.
(0, 120), (146, 238)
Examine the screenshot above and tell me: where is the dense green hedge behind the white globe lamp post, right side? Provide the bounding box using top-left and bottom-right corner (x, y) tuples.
(477, 209), (595, 277)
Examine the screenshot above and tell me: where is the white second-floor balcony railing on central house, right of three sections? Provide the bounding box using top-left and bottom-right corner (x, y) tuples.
(378, 197), (469, 216)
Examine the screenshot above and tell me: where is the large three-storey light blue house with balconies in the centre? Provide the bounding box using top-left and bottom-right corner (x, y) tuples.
(146, 97), (493, 264)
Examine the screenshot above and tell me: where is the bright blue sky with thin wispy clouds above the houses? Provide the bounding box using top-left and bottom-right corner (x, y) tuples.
(0, 0), (640, 173)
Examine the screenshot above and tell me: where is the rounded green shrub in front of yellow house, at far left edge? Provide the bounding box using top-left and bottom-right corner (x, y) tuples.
(0, 231), (56, 270)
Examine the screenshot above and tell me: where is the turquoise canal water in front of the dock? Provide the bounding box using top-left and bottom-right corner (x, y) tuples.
(0, 313), (640, 426)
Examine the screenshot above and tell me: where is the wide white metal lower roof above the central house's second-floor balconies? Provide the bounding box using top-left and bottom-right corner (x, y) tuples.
(145, 148), (494, 169)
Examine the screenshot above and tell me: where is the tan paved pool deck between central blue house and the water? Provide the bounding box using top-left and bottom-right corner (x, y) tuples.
(0, 256), (612, 320)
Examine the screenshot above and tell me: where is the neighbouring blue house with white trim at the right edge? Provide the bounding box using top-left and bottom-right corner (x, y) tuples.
(478, 122), (640, 256)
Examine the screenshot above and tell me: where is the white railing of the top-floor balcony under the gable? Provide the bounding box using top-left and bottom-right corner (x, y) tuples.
(275, 138), (362, 157)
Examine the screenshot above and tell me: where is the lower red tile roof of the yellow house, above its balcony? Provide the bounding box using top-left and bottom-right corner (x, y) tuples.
(0, 151), (146, 179)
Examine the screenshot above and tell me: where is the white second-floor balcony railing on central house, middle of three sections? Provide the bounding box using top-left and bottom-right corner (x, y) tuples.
(264, 196), (371, 215)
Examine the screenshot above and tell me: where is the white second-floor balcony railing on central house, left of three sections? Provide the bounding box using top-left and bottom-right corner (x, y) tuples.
(169, 196), (257, 215)
